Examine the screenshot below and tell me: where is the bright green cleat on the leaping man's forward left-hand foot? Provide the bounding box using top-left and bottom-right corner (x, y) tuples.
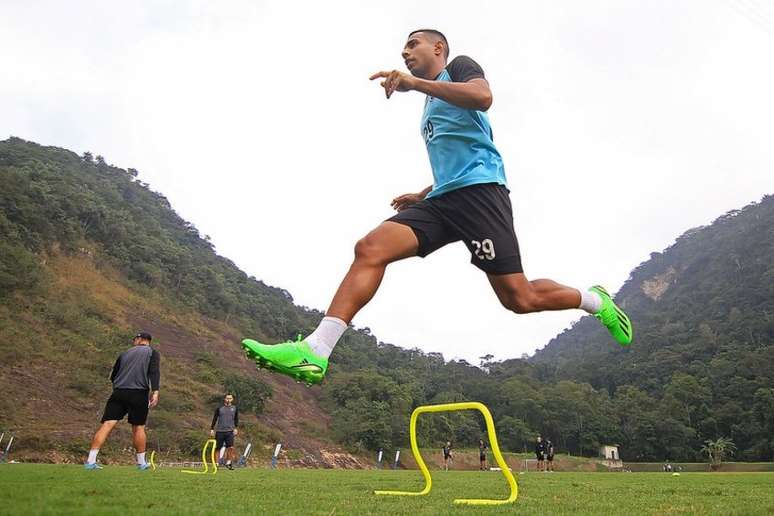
(242, 335), (328, 385)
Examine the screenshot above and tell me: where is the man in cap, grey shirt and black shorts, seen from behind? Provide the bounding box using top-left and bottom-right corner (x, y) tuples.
(85, 332), (161, 470)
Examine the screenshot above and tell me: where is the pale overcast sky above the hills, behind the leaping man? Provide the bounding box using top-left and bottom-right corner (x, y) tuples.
(0, 0), (774, 363)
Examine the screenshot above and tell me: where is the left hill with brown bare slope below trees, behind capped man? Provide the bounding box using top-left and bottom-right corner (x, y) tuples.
(0, 139), (370, 466)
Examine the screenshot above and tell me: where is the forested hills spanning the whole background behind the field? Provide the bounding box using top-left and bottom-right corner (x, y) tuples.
(0, 138), (774, 465)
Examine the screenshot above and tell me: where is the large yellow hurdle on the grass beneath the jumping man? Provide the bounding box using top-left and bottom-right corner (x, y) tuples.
(374, 401), (519, 505)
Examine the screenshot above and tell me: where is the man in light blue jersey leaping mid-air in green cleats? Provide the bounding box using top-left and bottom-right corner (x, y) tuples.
(242, 29), (632, 384)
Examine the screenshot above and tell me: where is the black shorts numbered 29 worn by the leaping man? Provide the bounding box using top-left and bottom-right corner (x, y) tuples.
(387, 183), (524, 274)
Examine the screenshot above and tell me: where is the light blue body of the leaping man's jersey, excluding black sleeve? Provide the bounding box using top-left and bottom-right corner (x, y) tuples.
(422, 69), (507, 198)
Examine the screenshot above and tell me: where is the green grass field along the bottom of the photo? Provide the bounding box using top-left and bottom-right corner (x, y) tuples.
(0, 464), (774, 516)
